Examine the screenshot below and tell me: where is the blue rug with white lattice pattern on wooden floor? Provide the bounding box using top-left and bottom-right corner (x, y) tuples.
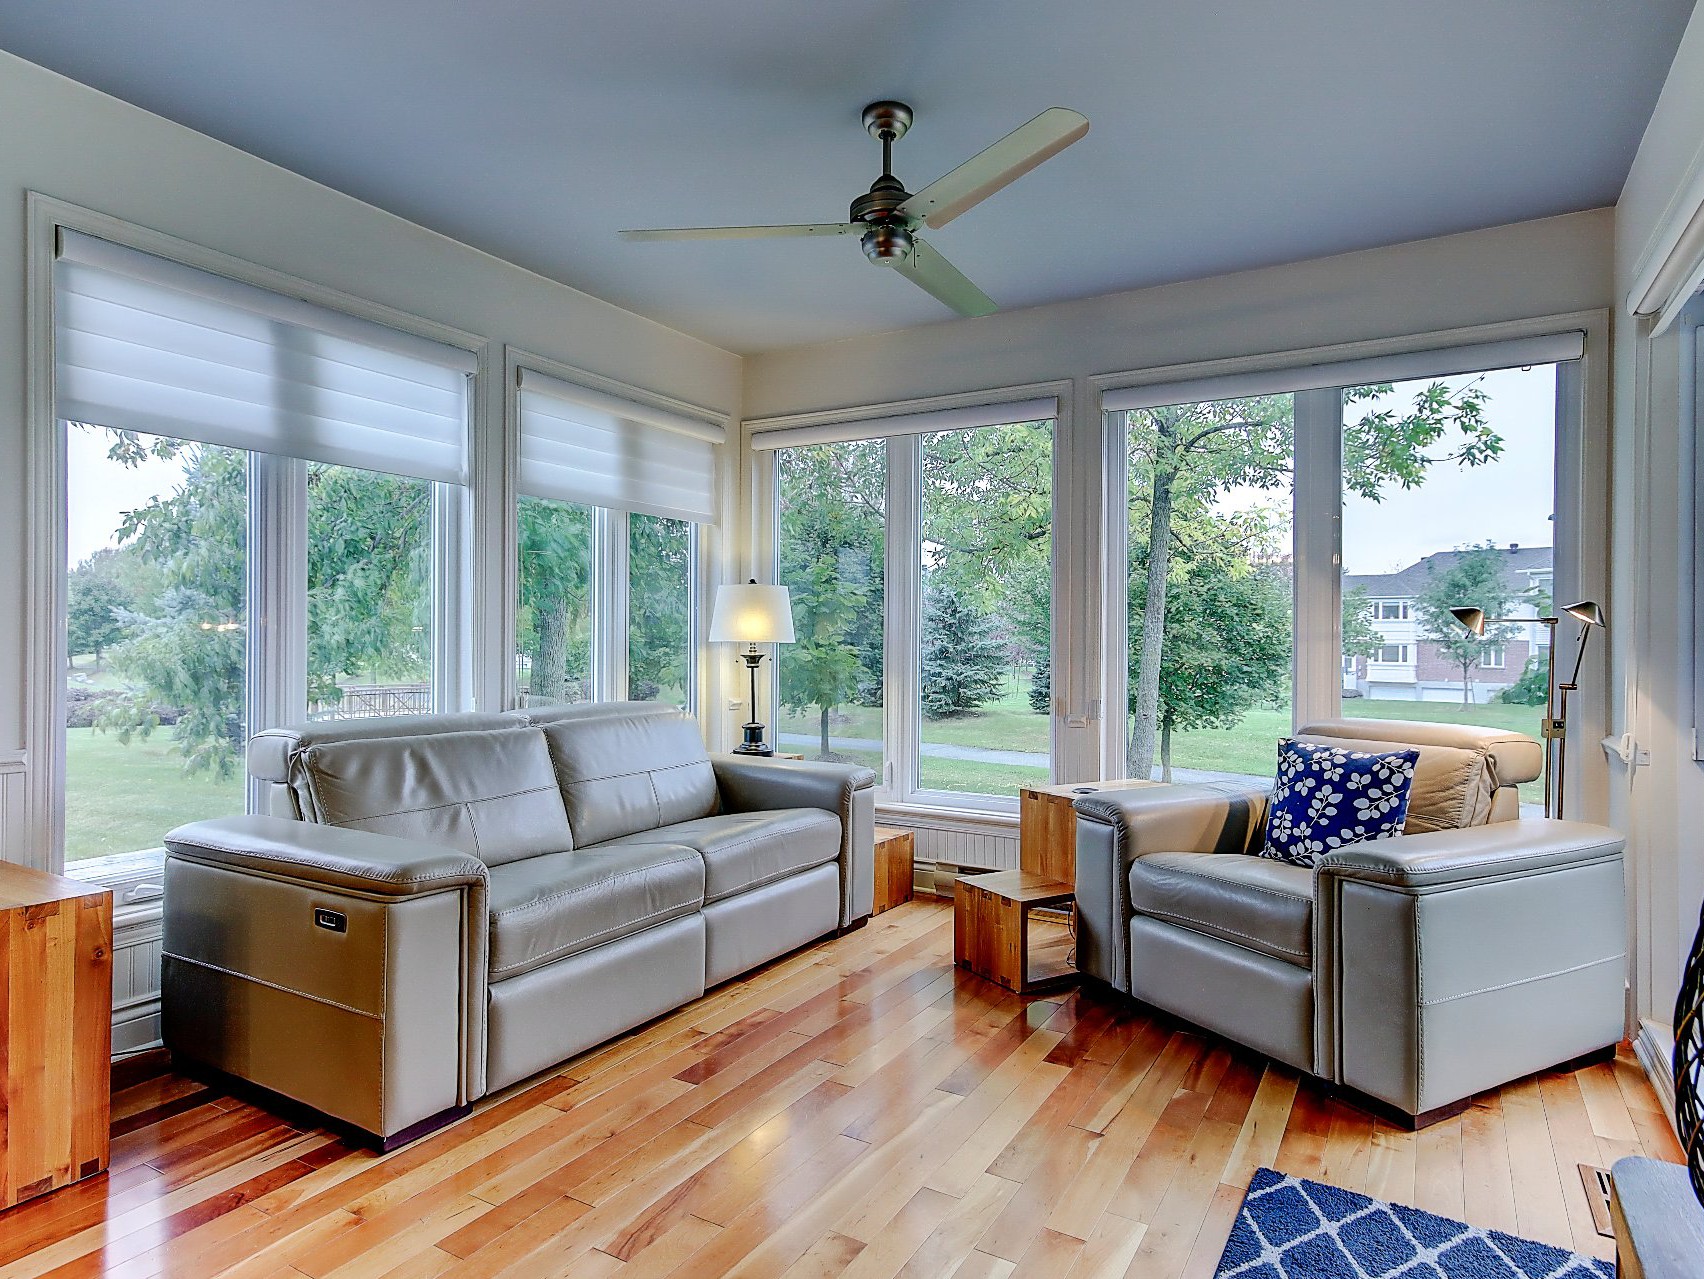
(1213, 1168), (1615, 1279)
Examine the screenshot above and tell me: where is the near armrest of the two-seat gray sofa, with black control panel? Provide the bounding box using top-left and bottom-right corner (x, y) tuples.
(162, 816), (489, 1144)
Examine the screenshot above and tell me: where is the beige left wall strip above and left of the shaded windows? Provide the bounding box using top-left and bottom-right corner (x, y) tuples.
(0, 53), (741, 861)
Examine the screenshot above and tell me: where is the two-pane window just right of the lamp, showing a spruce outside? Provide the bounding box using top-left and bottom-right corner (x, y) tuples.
(770, 399), (1055, 807)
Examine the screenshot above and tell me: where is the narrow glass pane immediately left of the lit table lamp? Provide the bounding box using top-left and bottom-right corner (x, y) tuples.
(627, 514), (692, 710)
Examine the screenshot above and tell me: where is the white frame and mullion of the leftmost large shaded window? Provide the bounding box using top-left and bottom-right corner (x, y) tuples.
(17, 191), (489, 892)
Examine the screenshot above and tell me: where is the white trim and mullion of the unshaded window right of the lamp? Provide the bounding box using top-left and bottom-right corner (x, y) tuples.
(756, 381), (1070, 826)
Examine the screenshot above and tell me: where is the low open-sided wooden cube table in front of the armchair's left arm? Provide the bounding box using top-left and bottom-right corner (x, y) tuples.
(953, 870), (1077, 995)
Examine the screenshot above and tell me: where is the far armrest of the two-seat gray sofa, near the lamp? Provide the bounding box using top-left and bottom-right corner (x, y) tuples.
(711, 754), (876, 928)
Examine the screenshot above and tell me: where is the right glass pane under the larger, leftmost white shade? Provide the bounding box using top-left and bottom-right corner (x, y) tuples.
(308, 462), (433, 719)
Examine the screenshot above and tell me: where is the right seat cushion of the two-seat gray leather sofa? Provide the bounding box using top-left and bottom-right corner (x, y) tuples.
(607, 809), (840, 901)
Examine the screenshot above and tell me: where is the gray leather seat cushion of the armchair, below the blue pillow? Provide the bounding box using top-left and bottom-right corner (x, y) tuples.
(1130, 853), (1314, 967)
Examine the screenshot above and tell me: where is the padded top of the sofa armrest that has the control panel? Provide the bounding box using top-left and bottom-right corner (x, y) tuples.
(165, 816), (487, 898)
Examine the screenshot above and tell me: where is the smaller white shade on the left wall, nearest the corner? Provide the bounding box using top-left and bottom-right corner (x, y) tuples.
(520, 368), (726, 525)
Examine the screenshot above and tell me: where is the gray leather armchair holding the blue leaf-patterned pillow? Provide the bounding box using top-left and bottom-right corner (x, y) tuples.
(1075, 720), (1627, 1126)
